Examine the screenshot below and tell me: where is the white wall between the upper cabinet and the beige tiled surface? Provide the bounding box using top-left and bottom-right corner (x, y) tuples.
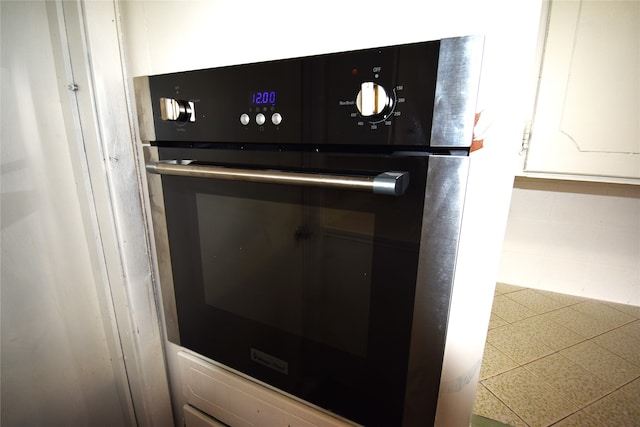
(498, 178), (640, 306)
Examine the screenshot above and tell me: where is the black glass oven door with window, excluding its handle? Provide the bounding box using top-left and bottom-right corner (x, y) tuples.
(159, 148), (430, 426)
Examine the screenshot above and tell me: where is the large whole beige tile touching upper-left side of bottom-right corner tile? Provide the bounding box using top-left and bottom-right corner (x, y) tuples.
(525, 353), (616, 408)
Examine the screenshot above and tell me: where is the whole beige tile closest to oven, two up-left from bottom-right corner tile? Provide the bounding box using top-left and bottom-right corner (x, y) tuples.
(487, 325), (553, 365)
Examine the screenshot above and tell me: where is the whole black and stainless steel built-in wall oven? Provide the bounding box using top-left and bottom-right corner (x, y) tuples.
(135, 37), (482, 426)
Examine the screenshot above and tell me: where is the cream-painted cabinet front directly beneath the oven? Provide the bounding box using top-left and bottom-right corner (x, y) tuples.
(178, 352), (356, 427)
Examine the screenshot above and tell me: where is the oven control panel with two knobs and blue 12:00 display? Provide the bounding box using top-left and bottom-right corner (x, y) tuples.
(135, 37), (482, 149)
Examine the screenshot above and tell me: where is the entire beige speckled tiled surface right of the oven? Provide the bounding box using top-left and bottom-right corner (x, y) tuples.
(474, 284), (640, 427)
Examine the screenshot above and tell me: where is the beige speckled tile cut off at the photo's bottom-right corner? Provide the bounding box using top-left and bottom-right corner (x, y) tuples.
(584, 390), (640, 427)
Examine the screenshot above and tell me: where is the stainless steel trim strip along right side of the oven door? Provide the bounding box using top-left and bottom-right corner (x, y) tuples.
(402, 155), (470, 426)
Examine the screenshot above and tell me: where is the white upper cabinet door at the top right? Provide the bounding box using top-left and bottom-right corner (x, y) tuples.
(524, 1), (640, 183)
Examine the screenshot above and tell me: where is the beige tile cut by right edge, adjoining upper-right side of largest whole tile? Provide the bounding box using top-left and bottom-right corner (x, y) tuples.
(560, 341), (640, 387)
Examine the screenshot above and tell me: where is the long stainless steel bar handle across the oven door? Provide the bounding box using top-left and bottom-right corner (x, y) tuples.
(146, 161), (409, 196)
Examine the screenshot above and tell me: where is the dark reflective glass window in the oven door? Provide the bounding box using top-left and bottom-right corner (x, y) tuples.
(197, 192), (375, 357)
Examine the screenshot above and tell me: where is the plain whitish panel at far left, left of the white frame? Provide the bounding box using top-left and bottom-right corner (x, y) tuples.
(0, 1), (132, 426)
